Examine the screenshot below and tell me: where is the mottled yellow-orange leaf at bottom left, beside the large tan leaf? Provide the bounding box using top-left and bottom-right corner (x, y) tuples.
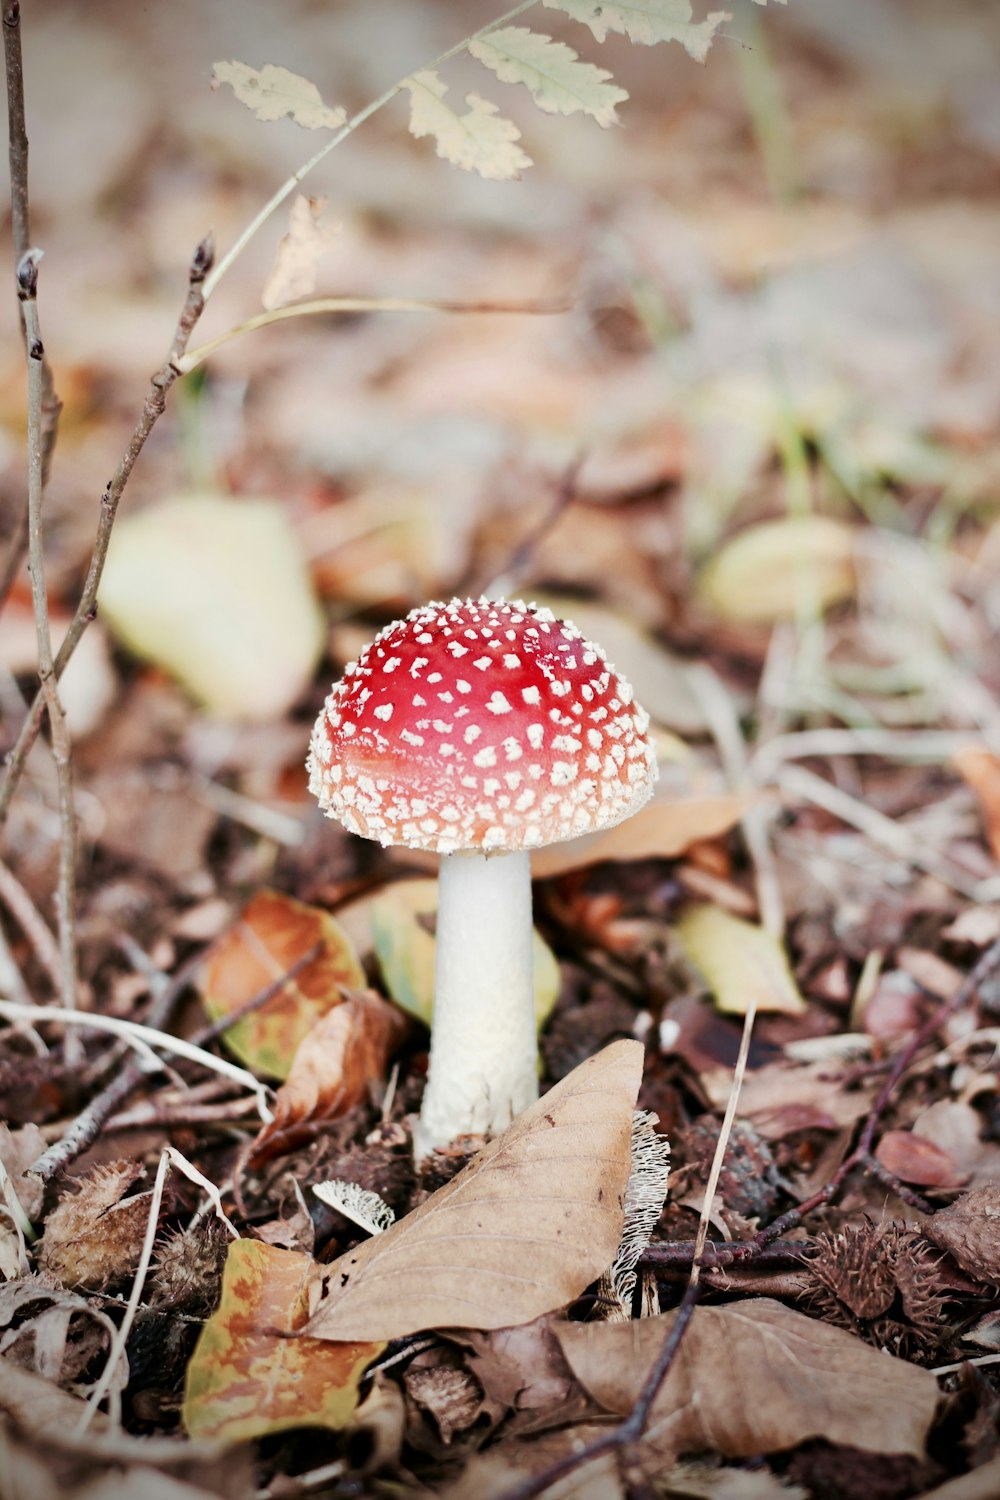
(181, 1239), (385, 1443)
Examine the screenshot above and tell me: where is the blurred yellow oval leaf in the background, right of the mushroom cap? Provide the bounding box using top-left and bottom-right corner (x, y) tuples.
(697, 516), (855, 624)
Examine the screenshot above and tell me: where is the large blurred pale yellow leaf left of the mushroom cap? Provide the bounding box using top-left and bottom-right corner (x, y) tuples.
(100, 494), (324, 720)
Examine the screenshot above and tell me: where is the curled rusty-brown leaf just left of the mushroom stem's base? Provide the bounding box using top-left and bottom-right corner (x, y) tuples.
(250, 990), (406, 1163)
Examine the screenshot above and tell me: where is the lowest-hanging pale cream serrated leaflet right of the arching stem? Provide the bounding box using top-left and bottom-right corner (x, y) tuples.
(402, 71), (531, 182)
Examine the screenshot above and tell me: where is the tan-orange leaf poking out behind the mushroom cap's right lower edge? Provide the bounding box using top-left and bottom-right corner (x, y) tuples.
(531, 792), (754, 878)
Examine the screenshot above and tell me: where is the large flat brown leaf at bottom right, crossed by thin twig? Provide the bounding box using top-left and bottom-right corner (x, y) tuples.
(556, 1298), (937, 1458)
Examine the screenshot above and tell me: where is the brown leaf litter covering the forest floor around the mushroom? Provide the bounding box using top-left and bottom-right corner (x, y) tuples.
(0, 0), (1000, 1500)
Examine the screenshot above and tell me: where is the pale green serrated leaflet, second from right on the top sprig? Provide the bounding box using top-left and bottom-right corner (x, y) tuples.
(469, 26), (628, 126)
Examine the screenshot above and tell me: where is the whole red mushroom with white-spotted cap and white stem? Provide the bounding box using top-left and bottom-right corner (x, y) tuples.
(309, 599), (657, 1158)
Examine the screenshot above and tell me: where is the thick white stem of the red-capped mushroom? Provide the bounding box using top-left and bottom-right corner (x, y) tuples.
(414, 852), (538, 1160)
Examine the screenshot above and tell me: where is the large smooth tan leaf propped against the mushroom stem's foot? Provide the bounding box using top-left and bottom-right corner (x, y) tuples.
(307, 1041), (643, 1340)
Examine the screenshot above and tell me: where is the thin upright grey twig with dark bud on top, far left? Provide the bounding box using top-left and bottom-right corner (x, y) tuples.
(16, 251), (81, 1067)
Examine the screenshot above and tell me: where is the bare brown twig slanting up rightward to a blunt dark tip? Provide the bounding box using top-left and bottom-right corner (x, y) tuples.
(0, 236), (214, 822)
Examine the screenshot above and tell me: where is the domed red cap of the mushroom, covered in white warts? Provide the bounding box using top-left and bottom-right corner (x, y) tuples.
(309, 599), (657, 854)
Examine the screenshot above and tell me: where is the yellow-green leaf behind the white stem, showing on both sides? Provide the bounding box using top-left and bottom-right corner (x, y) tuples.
(372, 881), (559, 1029)
